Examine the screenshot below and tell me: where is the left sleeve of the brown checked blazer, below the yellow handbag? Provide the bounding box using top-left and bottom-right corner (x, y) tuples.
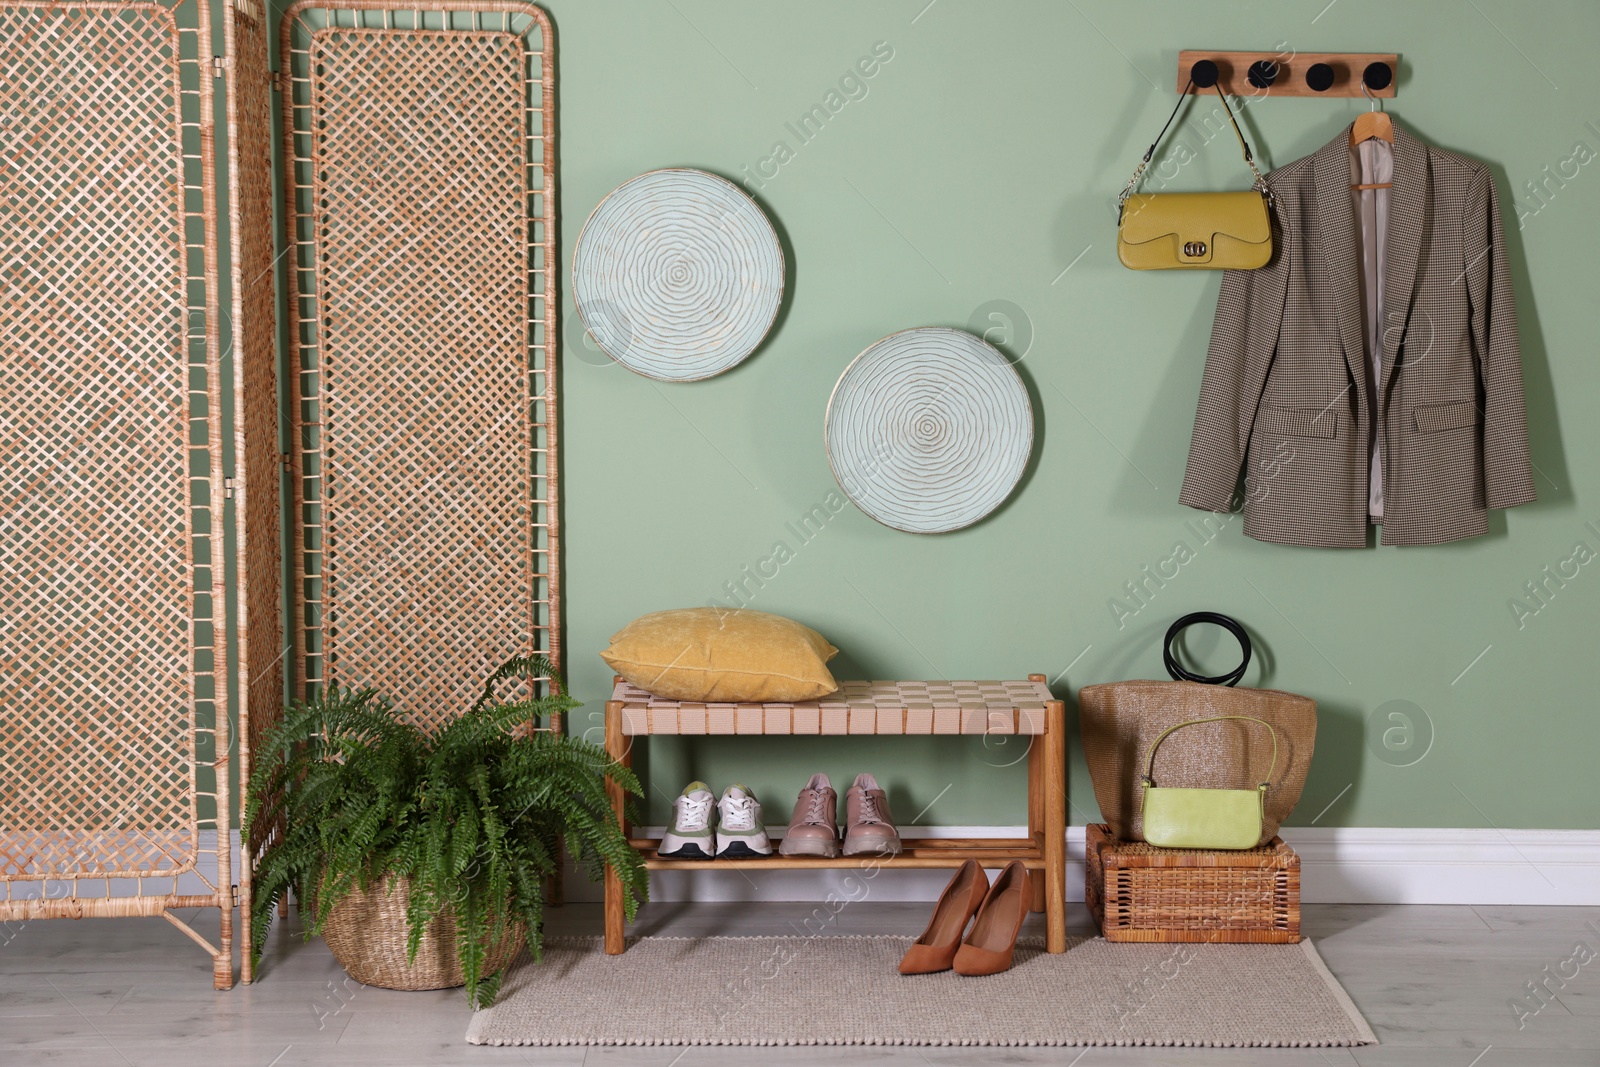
(1178, 220), (1291, 512)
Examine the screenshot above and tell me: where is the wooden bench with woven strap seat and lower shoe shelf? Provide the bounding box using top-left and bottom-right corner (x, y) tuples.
(605, 675), (1067, 955)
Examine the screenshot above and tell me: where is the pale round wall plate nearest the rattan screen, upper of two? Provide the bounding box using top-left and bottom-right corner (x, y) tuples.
(573, 170), (784, 382)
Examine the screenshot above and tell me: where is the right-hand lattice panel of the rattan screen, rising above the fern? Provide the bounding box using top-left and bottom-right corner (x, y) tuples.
(278, 0), (562, 726)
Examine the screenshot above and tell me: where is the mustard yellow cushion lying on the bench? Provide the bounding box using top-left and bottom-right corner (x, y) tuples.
(600, 608), (838, 704)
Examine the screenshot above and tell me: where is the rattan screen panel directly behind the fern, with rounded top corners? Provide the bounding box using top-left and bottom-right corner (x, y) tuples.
(280, 0), (560, 725)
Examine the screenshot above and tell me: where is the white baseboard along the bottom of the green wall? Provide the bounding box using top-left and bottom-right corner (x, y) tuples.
(566, 825), (1600, 905)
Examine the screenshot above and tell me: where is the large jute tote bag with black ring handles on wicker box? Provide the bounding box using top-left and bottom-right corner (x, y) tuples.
(1078, 611), (1317, 843)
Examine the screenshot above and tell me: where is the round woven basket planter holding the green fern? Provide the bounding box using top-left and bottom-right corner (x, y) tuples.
(322, 878), (525, 990)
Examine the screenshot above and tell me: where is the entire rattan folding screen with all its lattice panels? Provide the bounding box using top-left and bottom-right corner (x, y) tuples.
(0, 0), (560, 989)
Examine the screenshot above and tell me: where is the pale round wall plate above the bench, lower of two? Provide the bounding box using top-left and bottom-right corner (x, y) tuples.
(824, 326), (1034, 533)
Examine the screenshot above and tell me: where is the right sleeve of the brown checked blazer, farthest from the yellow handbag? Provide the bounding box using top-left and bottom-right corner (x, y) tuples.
(1461, 170), (1536, 507)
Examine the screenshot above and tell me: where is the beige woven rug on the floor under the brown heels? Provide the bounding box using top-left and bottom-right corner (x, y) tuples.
(467, 937), (1378, 1046)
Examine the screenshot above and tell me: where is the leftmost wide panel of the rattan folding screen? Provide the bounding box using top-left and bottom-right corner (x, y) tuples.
(0, 0), (234, 989)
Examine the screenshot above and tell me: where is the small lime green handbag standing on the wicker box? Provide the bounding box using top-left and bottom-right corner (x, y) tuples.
(1141, 715), (1278, 849)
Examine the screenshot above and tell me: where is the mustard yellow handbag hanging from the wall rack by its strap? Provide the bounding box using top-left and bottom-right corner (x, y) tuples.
(1117, 85), (1272, 270)
